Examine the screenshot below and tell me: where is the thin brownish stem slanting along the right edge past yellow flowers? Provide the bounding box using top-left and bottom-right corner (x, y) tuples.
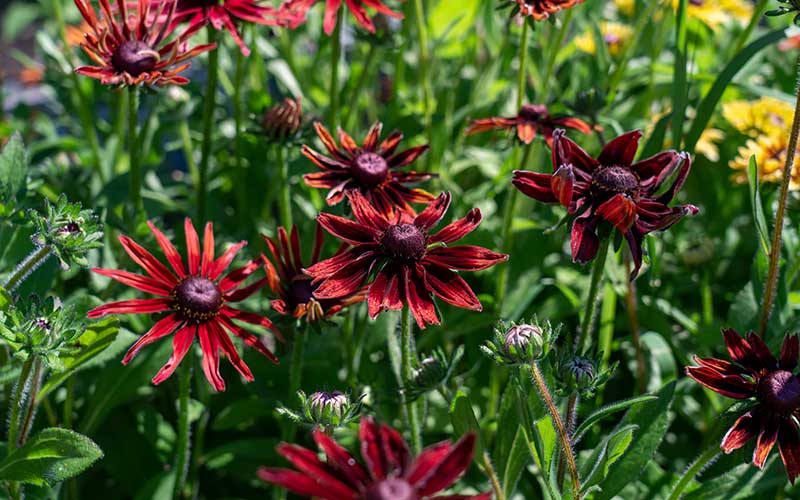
(759, 56), (800, 337)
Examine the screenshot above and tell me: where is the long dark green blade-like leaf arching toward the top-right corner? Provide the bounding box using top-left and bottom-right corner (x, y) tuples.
(673, 29), (787, 151)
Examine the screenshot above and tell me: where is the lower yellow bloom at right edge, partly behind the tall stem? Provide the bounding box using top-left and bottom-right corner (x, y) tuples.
(729, 135), (800, 190)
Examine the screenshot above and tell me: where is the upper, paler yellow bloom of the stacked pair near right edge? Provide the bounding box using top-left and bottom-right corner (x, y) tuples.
(722, 97), (794, 137)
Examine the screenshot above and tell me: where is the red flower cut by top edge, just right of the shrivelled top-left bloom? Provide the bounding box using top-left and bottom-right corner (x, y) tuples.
(171, 0), (289, 56)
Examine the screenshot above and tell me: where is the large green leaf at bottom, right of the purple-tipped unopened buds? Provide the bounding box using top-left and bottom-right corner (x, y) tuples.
(595, 382), (675, 500)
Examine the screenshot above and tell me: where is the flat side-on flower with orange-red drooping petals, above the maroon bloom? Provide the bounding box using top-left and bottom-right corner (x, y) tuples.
(464, 104), (592, 146)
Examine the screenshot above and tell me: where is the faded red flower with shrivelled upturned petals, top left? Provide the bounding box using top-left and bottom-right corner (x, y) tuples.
(75, 0), (216, 85)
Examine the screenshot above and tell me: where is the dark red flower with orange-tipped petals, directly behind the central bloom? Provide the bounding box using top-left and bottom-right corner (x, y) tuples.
(303, 122), (434, 217)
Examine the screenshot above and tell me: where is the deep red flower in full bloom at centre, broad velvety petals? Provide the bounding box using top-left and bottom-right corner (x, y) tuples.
(306, 192), (508, 328)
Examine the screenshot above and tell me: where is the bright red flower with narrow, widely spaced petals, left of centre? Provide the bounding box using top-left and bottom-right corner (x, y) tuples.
(88, 217), (280, 391)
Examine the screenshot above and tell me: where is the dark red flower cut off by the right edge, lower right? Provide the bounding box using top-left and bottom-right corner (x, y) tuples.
(686, 329), (800, 484)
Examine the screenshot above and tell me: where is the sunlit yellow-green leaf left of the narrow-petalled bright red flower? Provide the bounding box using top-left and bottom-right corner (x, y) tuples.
(37, 317), (122, 401)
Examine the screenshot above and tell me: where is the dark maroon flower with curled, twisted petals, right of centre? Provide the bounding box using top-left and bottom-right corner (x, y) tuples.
(513, 129), (698, 280)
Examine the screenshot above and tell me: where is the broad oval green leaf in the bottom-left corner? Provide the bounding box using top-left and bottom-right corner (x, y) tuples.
(0, 428), (103, 486)
